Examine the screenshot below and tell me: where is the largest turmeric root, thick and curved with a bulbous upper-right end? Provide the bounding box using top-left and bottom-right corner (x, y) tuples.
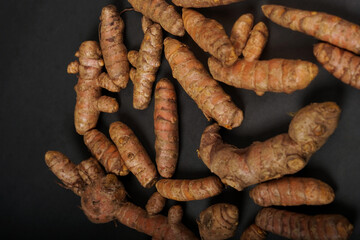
(199, 102), (340, 191)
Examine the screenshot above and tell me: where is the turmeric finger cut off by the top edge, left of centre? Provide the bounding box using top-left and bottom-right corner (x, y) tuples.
(129, 0), (185, 37)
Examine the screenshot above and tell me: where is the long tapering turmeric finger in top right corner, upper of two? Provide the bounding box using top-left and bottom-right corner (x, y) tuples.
(261, 5), (360, 54)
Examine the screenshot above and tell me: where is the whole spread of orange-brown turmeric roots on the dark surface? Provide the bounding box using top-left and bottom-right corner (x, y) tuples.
(45, 0), (360, 240)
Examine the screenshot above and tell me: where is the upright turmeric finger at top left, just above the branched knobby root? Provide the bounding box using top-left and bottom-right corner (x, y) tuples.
(99, 5), (129, 88)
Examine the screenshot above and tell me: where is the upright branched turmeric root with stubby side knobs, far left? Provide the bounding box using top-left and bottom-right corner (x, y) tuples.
(67, 41), (119, 135)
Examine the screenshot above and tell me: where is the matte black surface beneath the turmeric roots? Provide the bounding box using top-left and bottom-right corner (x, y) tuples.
(0, 0), (360, 240)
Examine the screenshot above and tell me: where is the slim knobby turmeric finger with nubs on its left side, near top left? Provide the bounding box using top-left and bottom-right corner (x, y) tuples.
(128, 17), (163, 110)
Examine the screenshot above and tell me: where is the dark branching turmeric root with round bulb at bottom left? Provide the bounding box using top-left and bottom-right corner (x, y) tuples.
(45, 151), (197, 240)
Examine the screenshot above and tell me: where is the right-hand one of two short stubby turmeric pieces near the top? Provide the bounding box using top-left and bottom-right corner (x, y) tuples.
(242, 22), (269, 62)
